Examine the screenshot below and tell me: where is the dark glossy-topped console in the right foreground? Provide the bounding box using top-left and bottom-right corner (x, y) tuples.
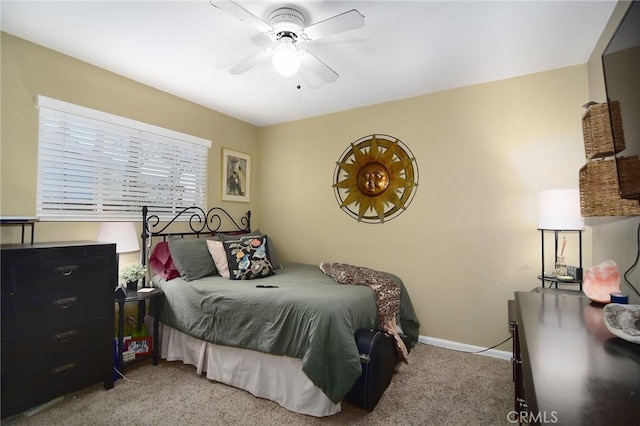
(509, 289), (640, 425)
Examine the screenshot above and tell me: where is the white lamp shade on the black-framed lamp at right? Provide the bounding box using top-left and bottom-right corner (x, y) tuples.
(538, 188), (584, 231)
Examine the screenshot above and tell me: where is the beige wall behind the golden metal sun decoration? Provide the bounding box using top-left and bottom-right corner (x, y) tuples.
(258, 65), (589, 349)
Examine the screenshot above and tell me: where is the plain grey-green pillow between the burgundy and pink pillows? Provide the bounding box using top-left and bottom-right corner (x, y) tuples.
(169, 238), (216, 281)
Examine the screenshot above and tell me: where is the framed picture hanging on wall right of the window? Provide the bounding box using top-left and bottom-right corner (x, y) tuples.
(221, 148), (251, 203)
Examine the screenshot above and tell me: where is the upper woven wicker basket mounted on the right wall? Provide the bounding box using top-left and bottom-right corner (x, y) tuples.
(582, 101), (625, 160)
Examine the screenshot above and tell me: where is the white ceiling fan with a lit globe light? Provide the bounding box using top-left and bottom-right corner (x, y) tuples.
(209, 0), (364, 83)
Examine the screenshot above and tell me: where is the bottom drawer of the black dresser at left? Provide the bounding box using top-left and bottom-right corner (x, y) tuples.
(1, 350), (113, 416)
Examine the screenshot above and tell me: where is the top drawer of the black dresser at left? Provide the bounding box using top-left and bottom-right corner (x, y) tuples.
(2, 256), (116, 296)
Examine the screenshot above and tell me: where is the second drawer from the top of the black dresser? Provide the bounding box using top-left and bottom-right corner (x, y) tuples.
(2, 286), (115, 337)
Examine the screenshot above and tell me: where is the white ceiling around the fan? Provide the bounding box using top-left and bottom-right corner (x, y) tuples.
(0, 0), (616, 126)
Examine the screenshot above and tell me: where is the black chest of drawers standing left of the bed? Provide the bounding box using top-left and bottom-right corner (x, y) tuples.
(0, 241), (118, 418)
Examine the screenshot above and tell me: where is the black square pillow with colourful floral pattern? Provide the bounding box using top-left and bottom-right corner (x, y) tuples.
(222, 235), (275, 280)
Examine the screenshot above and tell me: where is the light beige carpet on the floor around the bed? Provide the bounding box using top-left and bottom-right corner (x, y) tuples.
(2, 344), (513, 426)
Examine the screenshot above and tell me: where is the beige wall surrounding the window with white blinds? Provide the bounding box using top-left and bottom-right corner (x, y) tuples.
(0, 33), (260, 255)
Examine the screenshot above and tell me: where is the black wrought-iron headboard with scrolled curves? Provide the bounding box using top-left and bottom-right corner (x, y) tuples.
(140, 206), (251, 284)
